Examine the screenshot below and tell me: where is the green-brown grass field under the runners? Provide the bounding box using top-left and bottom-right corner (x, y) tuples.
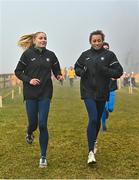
(0, 82), (139, 179)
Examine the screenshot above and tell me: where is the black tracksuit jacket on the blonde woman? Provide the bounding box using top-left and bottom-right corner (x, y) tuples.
(15, 47), (61, 100)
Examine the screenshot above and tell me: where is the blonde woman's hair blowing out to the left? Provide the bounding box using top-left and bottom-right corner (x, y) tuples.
(17, 32), (46, 49)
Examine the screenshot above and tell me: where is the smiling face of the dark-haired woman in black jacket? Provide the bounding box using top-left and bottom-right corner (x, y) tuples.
(90, 34), (103, 50)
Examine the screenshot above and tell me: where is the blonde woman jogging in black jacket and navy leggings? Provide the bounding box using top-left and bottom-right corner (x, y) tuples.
(15, 32), (62, 168)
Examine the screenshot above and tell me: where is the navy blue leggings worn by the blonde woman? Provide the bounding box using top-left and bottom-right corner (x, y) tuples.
(26, 99), (50, 157)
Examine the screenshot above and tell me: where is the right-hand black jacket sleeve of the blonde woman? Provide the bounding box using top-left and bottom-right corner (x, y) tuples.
(52, 53), (61, 78)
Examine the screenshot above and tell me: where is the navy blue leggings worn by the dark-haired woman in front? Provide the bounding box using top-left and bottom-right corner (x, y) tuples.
(84, 99), (105, 151)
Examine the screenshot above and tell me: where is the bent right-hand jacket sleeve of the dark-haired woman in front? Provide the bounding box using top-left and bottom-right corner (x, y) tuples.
(99, 53), (123, 79)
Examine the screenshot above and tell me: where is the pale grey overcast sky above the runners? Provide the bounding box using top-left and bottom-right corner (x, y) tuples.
(0, 0), (139, 74)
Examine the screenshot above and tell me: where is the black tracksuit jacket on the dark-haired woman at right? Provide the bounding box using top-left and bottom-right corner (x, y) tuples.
(74, 48), (123, 101)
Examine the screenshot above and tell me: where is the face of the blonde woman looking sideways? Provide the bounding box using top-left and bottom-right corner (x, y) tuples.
(33, 33), (47, 48)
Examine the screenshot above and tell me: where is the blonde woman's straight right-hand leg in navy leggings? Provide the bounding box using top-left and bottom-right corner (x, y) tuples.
(39, 99), (50, 157)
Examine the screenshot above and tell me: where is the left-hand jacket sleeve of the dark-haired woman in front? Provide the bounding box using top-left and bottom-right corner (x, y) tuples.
(74, 53), (87, 77)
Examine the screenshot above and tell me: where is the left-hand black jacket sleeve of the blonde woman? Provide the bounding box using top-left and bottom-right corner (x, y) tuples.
(14, 53), (31, 83)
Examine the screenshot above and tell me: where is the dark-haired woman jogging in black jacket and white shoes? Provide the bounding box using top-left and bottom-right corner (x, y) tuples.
(74, 30), (123, 164)
